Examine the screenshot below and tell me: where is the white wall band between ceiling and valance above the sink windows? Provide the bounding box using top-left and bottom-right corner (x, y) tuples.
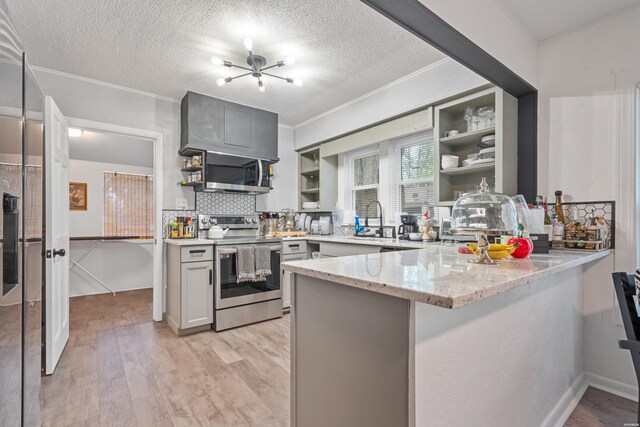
(295, 59), (487, 149)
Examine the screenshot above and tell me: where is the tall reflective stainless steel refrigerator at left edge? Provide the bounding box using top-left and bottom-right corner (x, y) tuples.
(0, 0), (44, 426)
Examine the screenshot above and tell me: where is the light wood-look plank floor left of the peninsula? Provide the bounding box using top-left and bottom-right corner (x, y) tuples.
(41, 290), (289, 426)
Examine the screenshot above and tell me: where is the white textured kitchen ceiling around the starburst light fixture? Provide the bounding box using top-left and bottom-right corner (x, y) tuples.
(6, 0), (444, 125)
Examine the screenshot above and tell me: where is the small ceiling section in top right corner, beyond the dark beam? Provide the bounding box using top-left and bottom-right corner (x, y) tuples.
(499, 0), (640, 41)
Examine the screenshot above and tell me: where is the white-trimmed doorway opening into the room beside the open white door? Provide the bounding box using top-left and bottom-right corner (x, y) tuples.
(67, 118), (163, 322)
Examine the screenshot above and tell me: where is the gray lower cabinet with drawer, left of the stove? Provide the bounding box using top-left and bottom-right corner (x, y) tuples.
(166, 245), (214, 335)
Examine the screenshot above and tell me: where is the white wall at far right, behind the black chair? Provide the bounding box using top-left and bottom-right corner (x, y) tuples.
(538, 9), (640, 400)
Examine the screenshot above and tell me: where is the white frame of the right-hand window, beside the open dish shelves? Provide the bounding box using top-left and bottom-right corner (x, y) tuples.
(389, 129), (437, 221)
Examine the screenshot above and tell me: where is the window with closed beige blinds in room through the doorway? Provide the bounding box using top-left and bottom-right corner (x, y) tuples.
(102, 172), (154, 237)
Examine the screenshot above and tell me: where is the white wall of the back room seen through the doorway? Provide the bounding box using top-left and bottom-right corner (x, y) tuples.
(69, 159), (153, 296)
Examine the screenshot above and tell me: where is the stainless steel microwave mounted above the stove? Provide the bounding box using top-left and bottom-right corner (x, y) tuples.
(204, 152), (271, 194)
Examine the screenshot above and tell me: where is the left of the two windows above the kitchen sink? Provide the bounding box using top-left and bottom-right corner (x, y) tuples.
(348, 150), (380, 218)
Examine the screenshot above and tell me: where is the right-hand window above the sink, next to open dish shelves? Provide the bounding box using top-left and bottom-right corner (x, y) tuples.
(391, 131), (435, 214)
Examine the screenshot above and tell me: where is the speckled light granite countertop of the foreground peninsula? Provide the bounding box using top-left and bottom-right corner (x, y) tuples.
(282, 243), (612, 308)
